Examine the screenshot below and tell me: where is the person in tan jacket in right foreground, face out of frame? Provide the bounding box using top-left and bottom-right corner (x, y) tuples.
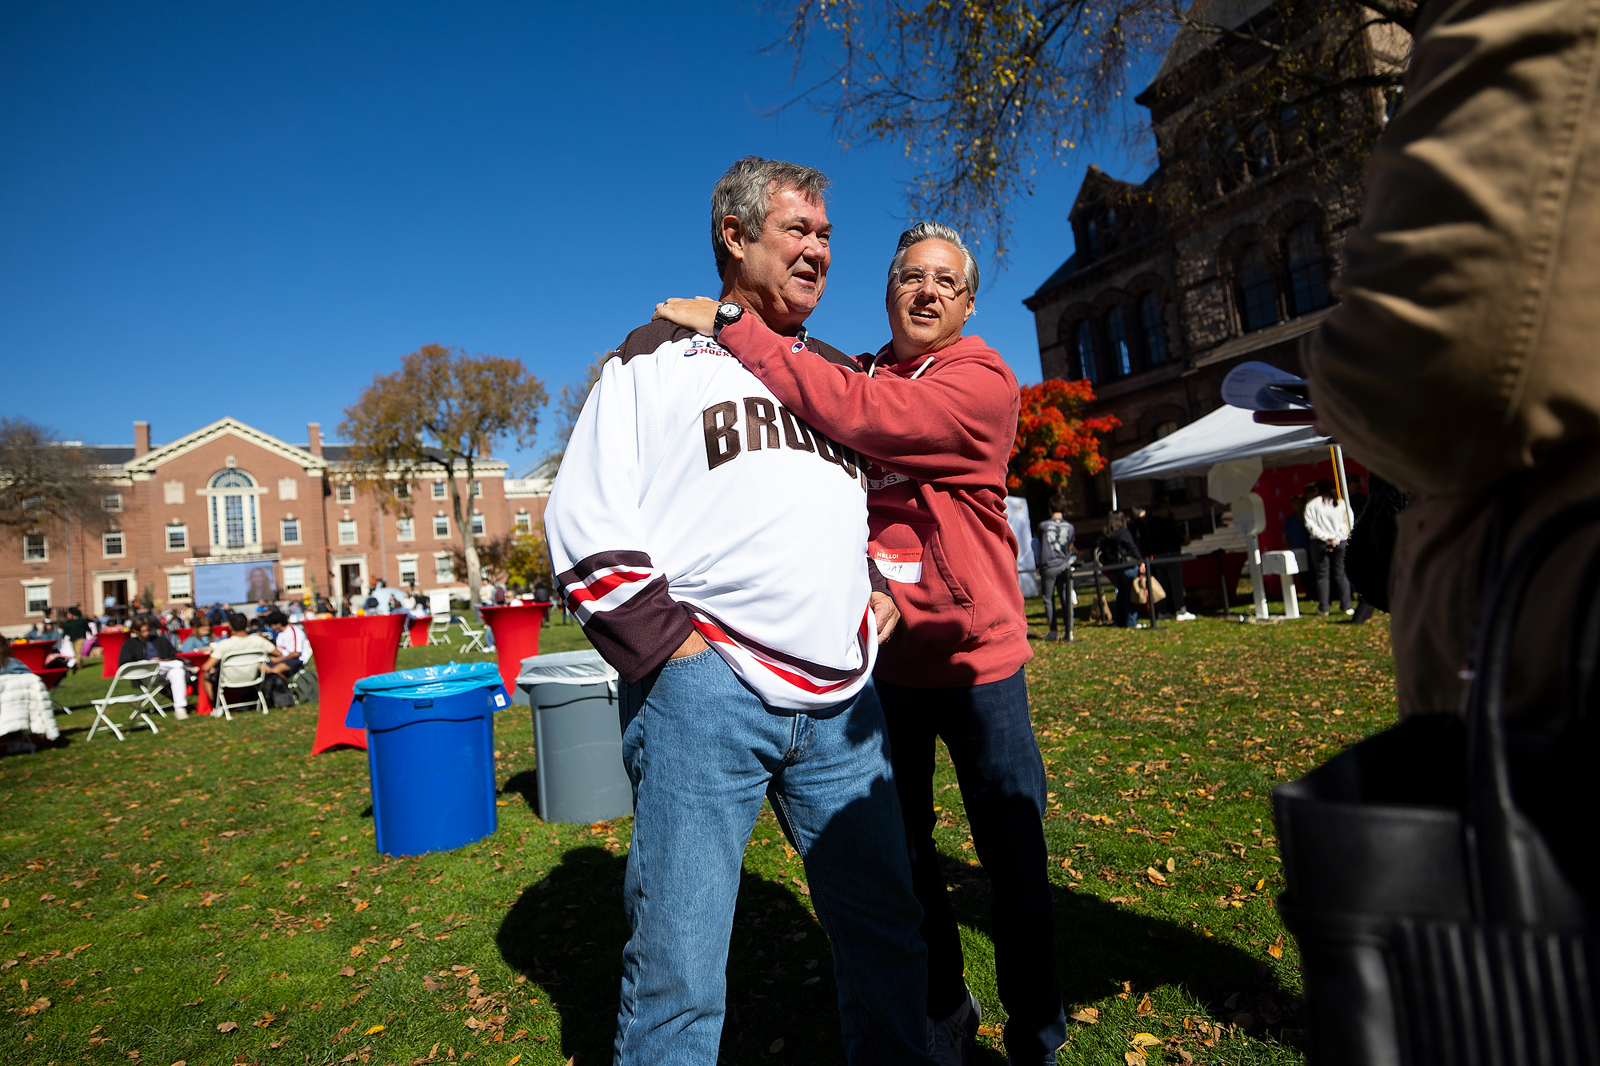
(1307, 0), (1600, 719)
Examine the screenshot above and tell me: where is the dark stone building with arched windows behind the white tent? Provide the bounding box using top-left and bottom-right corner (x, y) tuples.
(1024, 0), (1405, 533)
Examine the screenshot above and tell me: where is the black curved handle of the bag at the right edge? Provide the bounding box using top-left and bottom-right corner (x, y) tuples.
(1467, 498), (1600, 925)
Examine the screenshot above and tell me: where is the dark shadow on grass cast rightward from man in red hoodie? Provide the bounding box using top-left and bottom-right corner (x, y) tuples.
(941, 853), (1302, 1043)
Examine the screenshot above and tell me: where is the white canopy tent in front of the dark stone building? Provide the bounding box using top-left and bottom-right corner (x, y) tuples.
(1110, 407), (1349, 618)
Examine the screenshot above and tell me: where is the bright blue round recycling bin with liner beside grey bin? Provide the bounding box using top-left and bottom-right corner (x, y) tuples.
(344, 663), (510, 855)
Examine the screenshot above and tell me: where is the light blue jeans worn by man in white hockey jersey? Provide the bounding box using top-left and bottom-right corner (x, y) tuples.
(614, 650), (931, 1066)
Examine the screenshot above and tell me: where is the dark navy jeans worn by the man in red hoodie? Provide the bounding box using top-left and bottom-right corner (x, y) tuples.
(877, 669), (1067, 1066)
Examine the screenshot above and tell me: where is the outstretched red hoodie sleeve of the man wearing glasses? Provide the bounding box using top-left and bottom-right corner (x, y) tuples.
(717, 315), (1019, 488)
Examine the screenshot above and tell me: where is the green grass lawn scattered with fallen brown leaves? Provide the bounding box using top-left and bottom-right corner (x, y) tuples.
(0, 602), (1394, 1066)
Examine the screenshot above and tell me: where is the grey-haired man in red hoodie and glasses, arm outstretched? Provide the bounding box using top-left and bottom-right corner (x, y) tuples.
(656, 222), (1067, 1066)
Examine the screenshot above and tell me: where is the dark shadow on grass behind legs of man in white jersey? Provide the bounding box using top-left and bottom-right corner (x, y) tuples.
(494, 847), (845, 1066)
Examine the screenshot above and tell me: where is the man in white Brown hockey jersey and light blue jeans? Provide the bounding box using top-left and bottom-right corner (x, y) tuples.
(544, 157), (931, 1066)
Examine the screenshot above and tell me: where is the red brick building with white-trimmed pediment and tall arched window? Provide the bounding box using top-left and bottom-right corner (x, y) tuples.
(0, 418), (549, 635)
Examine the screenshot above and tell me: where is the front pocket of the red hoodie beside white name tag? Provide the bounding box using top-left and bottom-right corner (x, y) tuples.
(867, 522), (973, 648)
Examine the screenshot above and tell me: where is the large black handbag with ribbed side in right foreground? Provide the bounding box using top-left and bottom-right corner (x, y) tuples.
(1272, 501), (1600, 1066)
